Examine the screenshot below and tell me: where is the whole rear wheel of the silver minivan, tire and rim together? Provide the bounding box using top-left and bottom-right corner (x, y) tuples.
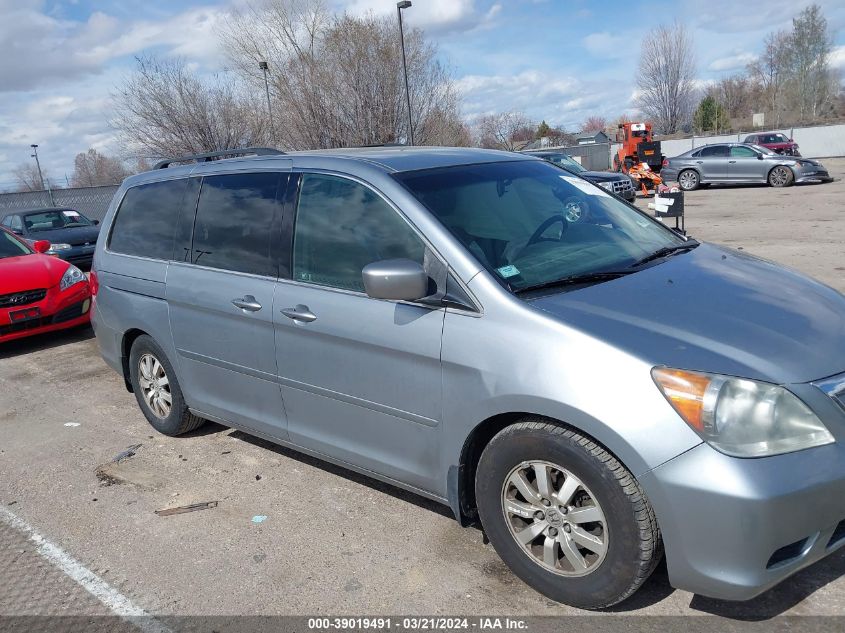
(129, 334), (205, 435)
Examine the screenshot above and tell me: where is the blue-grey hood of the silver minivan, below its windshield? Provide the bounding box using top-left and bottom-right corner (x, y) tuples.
(530, 244), (845, 383)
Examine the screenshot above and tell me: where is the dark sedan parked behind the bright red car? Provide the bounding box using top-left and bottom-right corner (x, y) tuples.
(0, 207), (100, 267)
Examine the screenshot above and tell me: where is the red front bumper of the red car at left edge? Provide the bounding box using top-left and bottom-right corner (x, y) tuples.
(0, 281), (91, 343)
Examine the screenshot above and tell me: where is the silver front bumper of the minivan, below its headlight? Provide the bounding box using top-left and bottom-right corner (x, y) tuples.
(640, 442), (845, 600)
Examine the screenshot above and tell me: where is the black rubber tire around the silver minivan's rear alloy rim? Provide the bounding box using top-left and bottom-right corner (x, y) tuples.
(129, 334), (205, 436)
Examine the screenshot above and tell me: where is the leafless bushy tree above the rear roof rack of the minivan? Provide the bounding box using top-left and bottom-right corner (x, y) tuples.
(112, 57), (267, 158)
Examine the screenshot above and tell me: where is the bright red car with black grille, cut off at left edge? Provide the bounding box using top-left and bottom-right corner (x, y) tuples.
(0, 227), (91, 343)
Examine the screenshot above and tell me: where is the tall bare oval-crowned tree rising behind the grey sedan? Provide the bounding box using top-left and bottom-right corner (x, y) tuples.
(637, 22), (696, 134)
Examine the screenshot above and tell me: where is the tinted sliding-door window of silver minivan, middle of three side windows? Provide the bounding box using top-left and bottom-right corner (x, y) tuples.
(192, 172), (281, 277)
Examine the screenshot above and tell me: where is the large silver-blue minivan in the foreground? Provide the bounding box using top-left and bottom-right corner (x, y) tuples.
(92, 147), (845, 608)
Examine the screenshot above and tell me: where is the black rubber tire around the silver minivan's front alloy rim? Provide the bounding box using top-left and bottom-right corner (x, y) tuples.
(475, 417), (663, 609)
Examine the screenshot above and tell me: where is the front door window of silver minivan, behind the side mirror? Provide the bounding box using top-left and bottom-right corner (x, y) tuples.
(293, 174), (425, 292)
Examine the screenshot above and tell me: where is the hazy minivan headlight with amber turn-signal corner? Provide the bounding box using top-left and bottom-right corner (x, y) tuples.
(651, 367), (834, 457)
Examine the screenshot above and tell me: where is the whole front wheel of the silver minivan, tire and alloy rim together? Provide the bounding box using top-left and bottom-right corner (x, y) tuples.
(475, 417), (663, 609)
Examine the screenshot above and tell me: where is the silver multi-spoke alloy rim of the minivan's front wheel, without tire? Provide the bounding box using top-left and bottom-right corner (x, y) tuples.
(502, 461), (608, 576)
